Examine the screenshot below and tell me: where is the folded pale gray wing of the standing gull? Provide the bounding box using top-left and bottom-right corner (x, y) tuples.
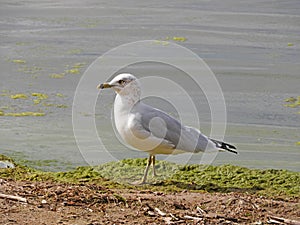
(132, 102), (212, 152)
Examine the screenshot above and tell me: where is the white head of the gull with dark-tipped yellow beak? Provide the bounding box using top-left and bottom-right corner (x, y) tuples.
(97, 73), (141, 98)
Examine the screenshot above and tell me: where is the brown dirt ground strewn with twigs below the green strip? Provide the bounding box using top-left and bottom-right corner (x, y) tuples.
(0, 179), (300, 225)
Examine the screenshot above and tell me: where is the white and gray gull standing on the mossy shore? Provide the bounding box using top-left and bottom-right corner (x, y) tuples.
(97, 73), (237, 184)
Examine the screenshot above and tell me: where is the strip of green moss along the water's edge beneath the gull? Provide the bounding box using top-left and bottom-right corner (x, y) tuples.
(0, 155), (300, 198)
